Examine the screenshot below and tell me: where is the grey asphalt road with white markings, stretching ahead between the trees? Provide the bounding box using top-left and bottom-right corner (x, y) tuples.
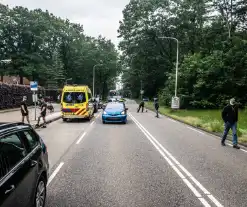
(38, 102), (247, 207)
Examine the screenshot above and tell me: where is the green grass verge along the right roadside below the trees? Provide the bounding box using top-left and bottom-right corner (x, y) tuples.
(145, 102), (247, 144)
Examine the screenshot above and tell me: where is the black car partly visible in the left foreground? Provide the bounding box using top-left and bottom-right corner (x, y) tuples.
(0, 123), (49, 207)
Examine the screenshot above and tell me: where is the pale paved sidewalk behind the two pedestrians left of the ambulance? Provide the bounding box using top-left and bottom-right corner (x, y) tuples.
(0, 104), (61, 125)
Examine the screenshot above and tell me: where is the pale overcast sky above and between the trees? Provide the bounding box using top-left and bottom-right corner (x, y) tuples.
(0, 0), (129, 44)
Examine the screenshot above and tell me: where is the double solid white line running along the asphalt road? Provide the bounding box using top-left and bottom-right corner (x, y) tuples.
(129, 114), (223, 207)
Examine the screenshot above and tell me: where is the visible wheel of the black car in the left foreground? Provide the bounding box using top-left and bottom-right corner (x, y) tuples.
(34, 176), (46, 207)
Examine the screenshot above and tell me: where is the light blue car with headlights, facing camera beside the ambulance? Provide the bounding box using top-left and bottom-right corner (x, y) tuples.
(102, 102), (128, 124)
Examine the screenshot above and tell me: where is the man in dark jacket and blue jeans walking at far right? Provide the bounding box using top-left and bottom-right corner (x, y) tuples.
(221, 98), (240, 149)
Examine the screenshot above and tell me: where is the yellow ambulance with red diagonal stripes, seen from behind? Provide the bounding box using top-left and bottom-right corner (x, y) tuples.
(61, 85), (94, 121)
